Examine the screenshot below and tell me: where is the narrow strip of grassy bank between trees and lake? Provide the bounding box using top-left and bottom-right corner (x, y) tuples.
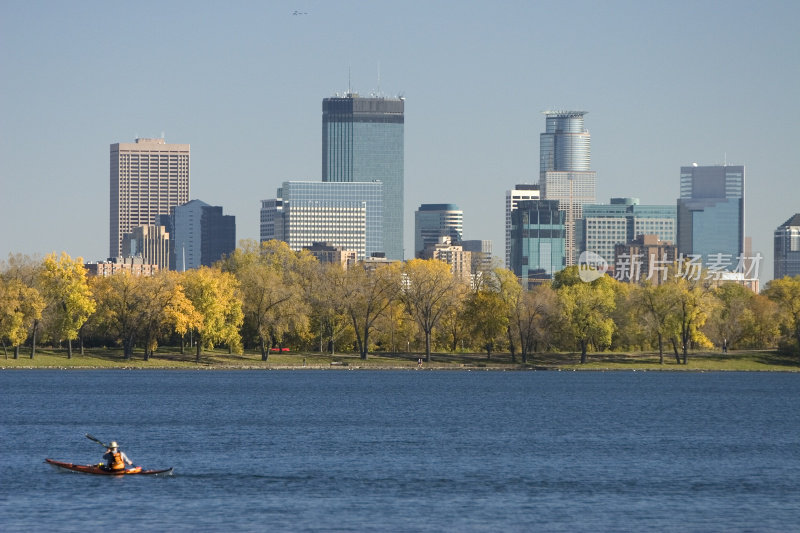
(0, 348), (800, 372)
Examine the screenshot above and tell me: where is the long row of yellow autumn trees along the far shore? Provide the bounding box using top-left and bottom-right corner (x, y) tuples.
(0, 241), (800, 364)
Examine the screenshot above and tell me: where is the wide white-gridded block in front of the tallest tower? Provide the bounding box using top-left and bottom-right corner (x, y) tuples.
(260, 181), (384, 260)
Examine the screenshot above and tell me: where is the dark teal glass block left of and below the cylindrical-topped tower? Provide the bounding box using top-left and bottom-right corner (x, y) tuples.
(511, 200), (566, 287)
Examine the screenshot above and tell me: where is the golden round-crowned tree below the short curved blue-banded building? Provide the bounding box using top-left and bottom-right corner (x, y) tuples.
(399, 259), (457, 362)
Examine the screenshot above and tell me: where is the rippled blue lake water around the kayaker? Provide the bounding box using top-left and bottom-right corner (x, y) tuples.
(0, 370), (800, 532)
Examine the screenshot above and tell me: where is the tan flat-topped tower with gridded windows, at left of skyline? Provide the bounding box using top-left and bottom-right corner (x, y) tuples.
(109, 139), (189, 257)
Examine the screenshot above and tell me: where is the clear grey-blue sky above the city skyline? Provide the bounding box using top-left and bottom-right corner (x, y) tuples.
(0, 0), (800, 283)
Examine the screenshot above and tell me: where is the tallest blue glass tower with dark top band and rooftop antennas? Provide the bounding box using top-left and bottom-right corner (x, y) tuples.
(322, 93), (405, 260)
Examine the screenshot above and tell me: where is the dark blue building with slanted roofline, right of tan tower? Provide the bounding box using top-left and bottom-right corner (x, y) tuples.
(166, 200), (236, 272)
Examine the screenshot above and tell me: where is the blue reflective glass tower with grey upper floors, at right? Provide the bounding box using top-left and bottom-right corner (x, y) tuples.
(677, 164), (745, 270)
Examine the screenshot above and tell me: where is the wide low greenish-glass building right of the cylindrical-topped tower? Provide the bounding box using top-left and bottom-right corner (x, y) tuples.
(575, 198), (676, 264)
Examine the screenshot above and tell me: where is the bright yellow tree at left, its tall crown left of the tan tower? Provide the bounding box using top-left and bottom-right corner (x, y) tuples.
(40, 252), (95, 358)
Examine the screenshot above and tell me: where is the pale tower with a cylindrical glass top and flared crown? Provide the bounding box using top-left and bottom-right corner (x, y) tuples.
(539, 111), (597, 265)
